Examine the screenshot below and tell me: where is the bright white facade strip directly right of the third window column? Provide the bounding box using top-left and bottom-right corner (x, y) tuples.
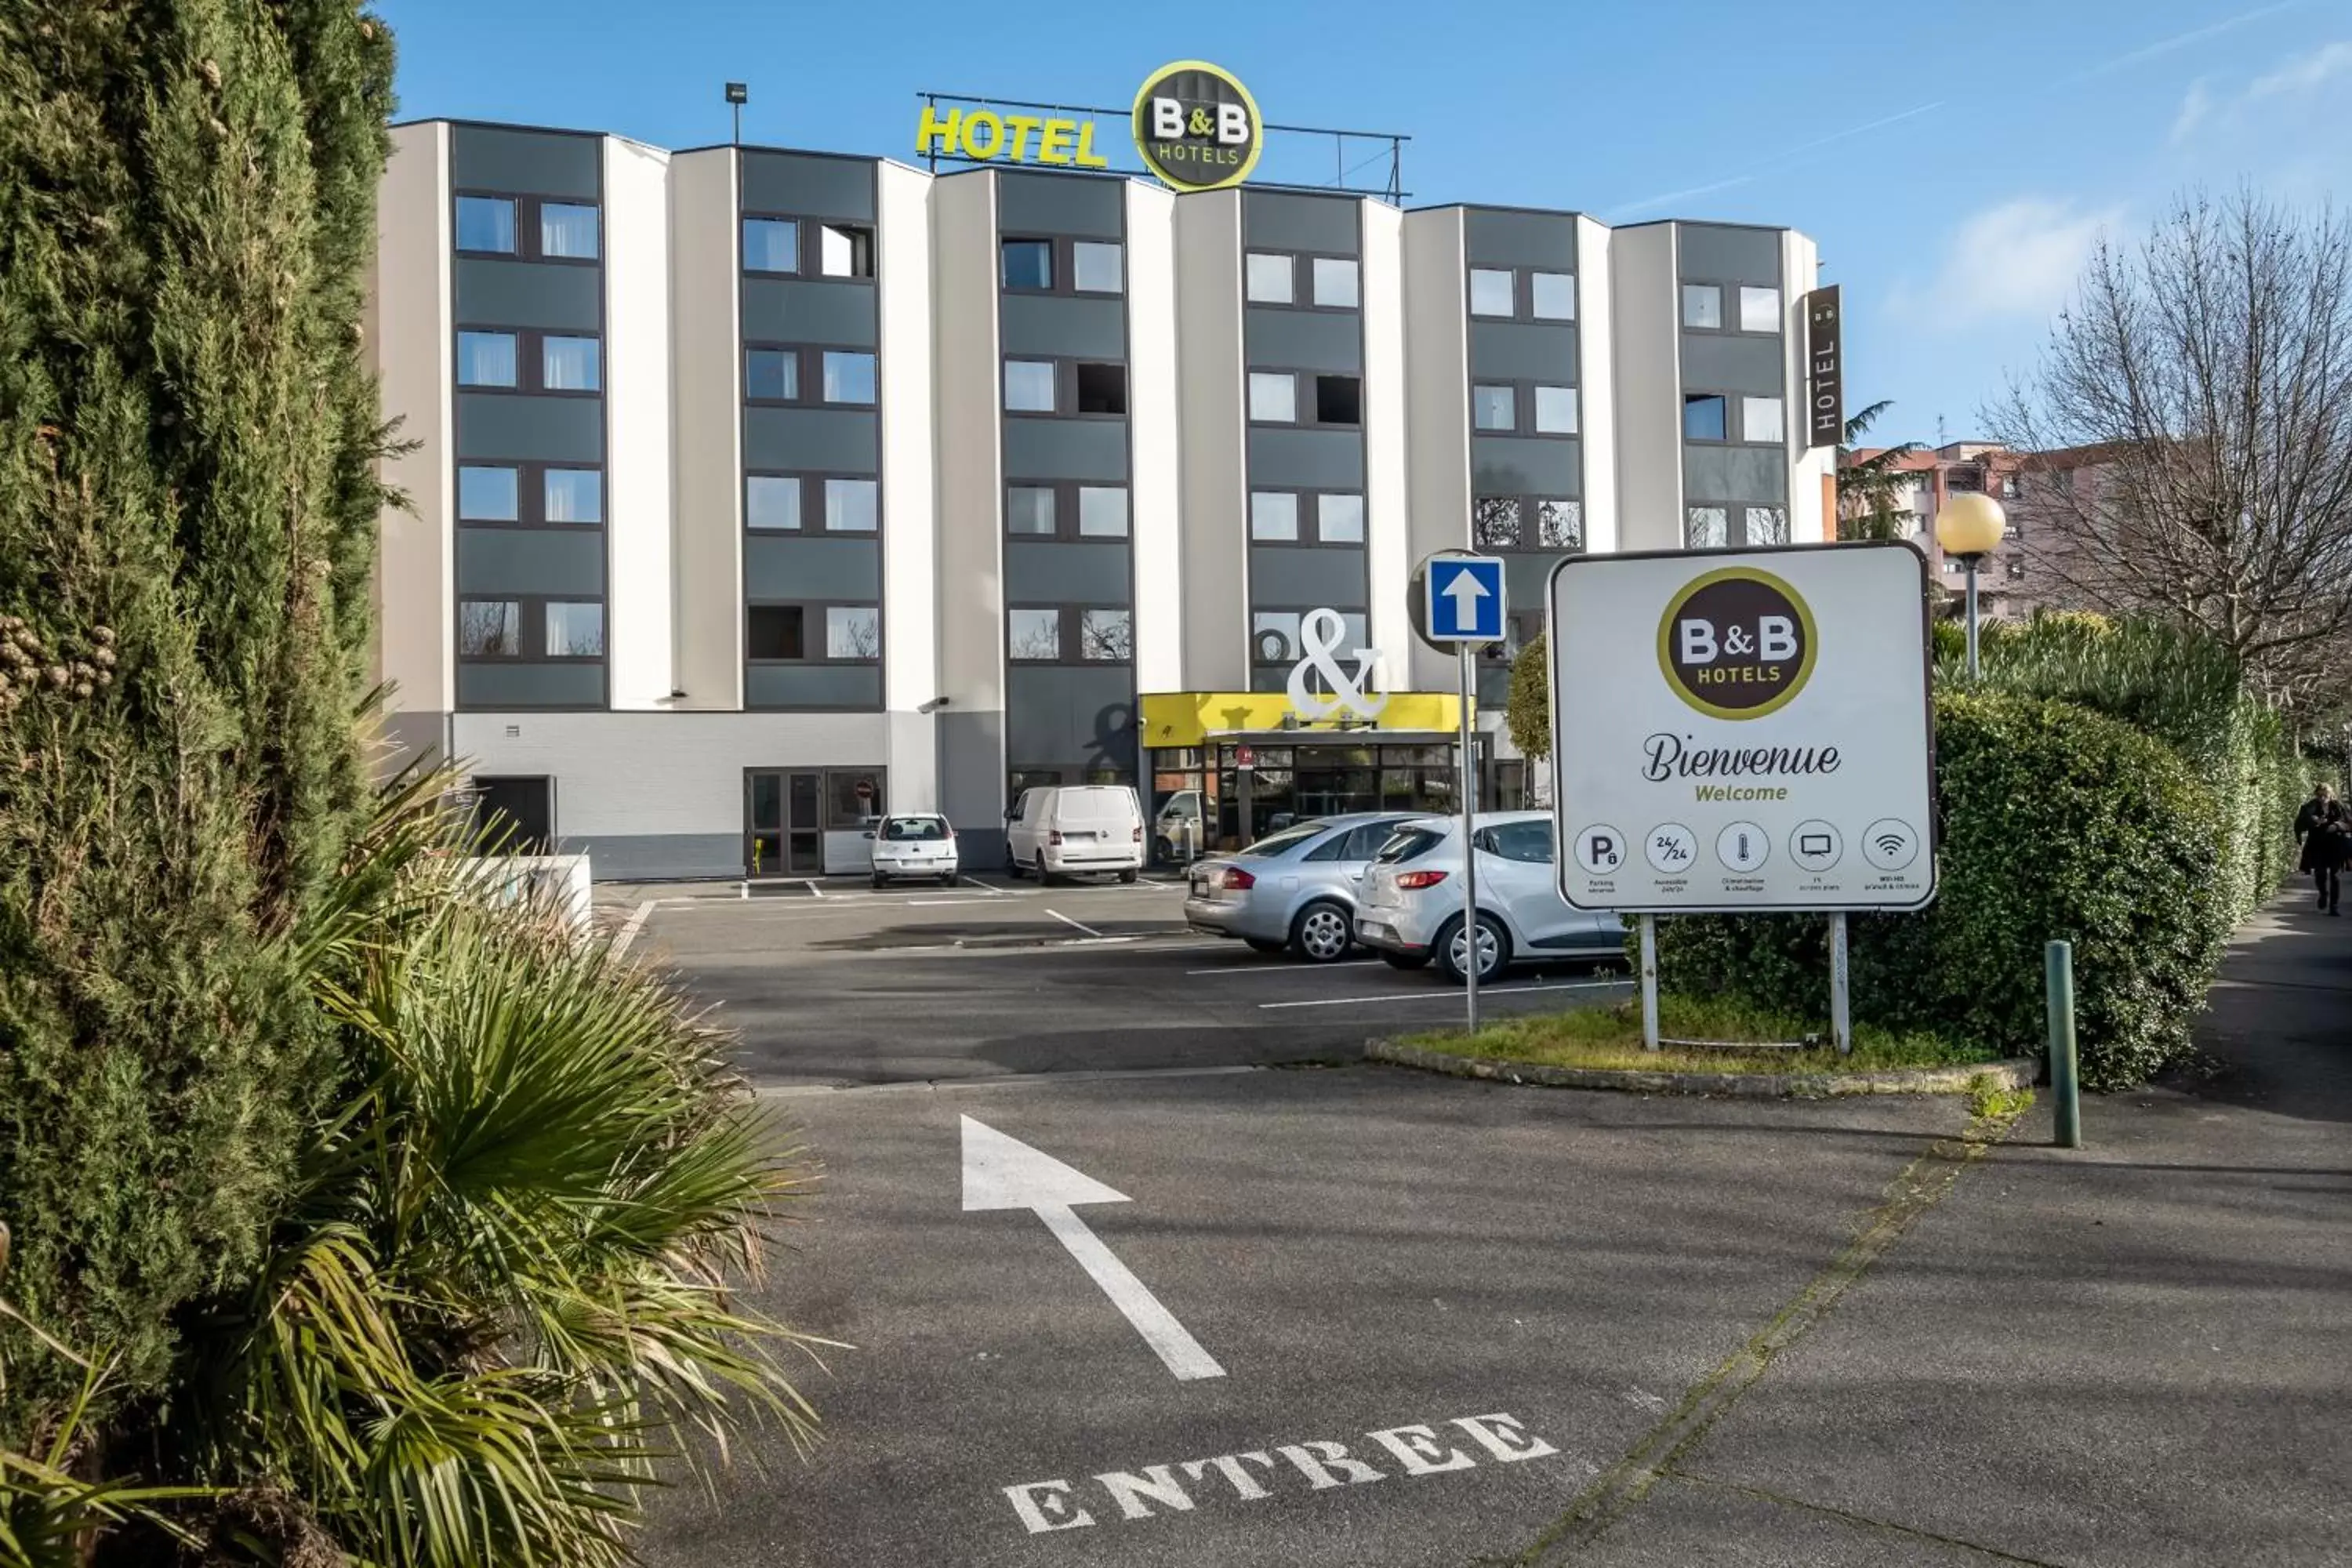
(1127, 181), (1185, 691)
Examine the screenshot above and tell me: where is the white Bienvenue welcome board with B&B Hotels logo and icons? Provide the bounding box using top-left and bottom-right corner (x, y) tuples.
(1545, 543), (1936, 914)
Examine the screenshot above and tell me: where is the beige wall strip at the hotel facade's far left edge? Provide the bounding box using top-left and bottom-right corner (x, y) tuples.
(367, 120), (456, 713)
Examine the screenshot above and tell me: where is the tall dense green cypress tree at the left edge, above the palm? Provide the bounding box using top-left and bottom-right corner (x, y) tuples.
(0, 0), (393, 1441)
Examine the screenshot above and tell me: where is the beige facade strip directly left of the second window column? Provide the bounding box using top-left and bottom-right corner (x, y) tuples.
(668, 148), (743, 710)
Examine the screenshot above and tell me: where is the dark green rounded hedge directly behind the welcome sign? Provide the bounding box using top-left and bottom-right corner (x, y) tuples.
(1658, 687), (2232, 1088)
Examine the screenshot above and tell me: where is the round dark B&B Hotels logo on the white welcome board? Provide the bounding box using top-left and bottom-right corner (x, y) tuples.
(1658, 567), (1818, 720)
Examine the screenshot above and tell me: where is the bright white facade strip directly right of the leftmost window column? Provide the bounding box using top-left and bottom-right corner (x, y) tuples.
(604, 136), (675, 710)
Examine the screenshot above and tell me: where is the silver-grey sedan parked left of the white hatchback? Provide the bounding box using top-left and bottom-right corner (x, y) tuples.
(1183, 811), (1411, 964)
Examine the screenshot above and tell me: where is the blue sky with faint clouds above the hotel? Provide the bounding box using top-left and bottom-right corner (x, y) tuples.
(381, 0), (2352, 442)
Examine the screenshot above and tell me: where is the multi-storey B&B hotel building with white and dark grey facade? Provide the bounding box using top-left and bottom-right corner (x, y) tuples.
(369, 120), (1835, 877)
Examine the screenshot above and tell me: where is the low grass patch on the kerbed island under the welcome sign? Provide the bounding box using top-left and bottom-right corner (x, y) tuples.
(1399, 992), (1999, 1072)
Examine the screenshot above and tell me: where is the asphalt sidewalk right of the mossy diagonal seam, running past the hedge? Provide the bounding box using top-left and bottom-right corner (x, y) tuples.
(1559, 895), (2352, 1568)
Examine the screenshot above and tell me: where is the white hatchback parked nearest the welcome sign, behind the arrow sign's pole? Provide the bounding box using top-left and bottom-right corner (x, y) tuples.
(1355, 811), (1625, 985)
